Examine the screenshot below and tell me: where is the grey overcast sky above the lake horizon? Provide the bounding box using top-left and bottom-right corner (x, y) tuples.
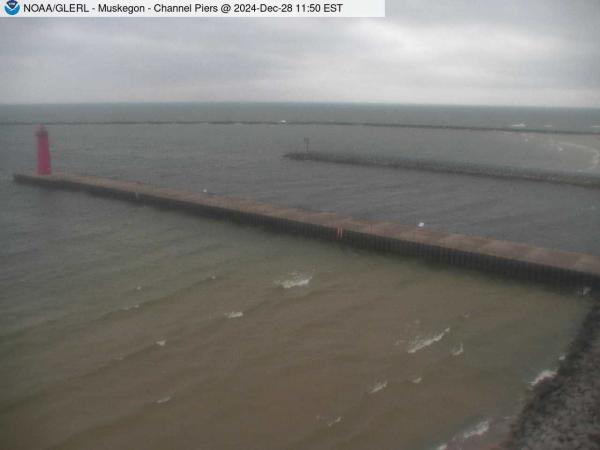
(0, 0), (600, 107)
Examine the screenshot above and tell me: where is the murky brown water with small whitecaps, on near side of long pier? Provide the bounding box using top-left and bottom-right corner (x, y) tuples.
(0, 192), (586, 450)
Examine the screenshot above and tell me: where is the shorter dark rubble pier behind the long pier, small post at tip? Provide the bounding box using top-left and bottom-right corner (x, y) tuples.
(285, 151), (600, 189)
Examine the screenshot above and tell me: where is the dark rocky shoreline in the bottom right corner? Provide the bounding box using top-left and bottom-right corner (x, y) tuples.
(500, 294), (600, 450)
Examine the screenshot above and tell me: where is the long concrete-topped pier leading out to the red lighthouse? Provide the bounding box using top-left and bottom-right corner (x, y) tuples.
(14, 174), (600, 287)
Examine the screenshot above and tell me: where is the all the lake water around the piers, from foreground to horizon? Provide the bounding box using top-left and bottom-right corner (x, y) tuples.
(0, 105), (600, 450)
